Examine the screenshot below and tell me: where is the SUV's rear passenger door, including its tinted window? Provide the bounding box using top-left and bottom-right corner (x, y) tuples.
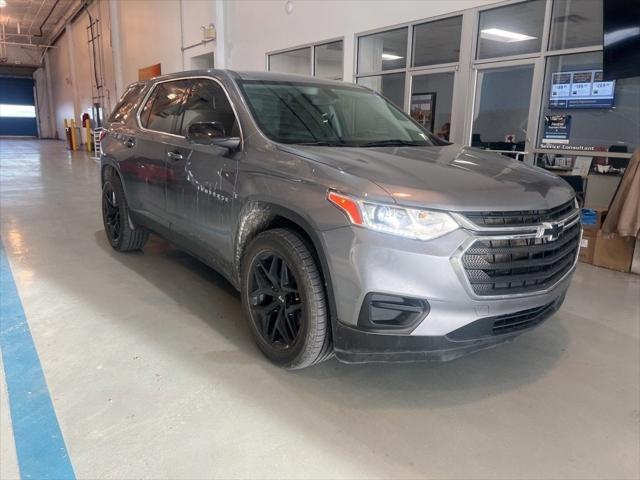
(121, 80), (189, 226)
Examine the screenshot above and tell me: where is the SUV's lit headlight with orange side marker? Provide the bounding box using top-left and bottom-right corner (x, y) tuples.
(327, 191), (458, 240)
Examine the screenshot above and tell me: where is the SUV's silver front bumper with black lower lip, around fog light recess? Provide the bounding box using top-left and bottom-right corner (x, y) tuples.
(323, 227), (575, 363)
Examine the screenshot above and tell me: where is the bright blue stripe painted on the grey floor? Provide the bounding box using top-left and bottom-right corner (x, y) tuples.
(0, 242), (75, 480)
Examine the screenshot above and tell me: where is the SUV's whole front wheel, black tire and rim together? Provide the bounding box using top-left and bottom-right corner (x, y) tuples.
(241, 228), (333, 369)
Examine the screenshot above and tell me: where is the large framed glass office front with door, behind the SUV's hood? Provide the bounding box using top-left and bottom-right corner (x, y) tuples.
(355, 0), (640, 168)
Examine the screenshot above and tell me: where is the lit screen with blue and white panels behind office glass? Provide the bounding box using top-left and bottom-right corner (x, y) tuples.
(549, 70), (615, 109)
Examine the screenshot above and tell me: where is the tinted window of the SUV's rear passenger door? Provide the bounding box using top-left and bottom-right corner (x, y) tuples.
(140, 80), (189, 133)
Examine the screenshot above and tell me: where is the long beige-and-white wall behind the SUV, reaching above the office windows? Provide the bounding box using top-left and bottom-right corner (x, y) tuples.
(42, 0), (504, 138)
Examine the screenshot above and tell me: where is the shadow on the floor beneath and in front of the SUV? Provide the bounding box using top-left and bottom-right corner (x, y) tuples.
(96, 231), (568, 408)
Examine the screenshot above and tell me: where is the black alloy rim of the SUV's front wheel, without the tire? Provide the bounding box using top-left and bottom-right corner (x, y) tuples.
(248, 252), (303, 351)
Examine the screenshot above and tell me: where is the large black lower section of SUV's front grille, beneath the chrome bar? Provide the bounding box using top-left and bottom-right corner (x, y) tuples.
(462, 223), (581, 296)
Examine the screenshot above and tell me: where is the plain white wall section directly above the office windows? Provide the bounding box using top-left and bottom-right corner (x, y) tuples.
(224, 0), (496, 81)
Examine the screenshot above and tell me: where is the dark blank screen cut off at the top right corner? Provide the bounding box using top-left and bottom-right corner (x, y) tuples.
(602, 0), (640, 80)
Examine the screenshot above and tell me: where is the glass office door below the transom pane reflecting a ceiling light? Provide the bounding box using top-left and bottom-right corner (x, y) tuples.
(469, 60), (536, 160)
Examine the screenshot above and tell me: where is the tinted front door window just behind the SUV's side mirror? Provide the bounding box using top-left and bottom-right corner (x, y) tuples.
(181, 79), (240, 137)
